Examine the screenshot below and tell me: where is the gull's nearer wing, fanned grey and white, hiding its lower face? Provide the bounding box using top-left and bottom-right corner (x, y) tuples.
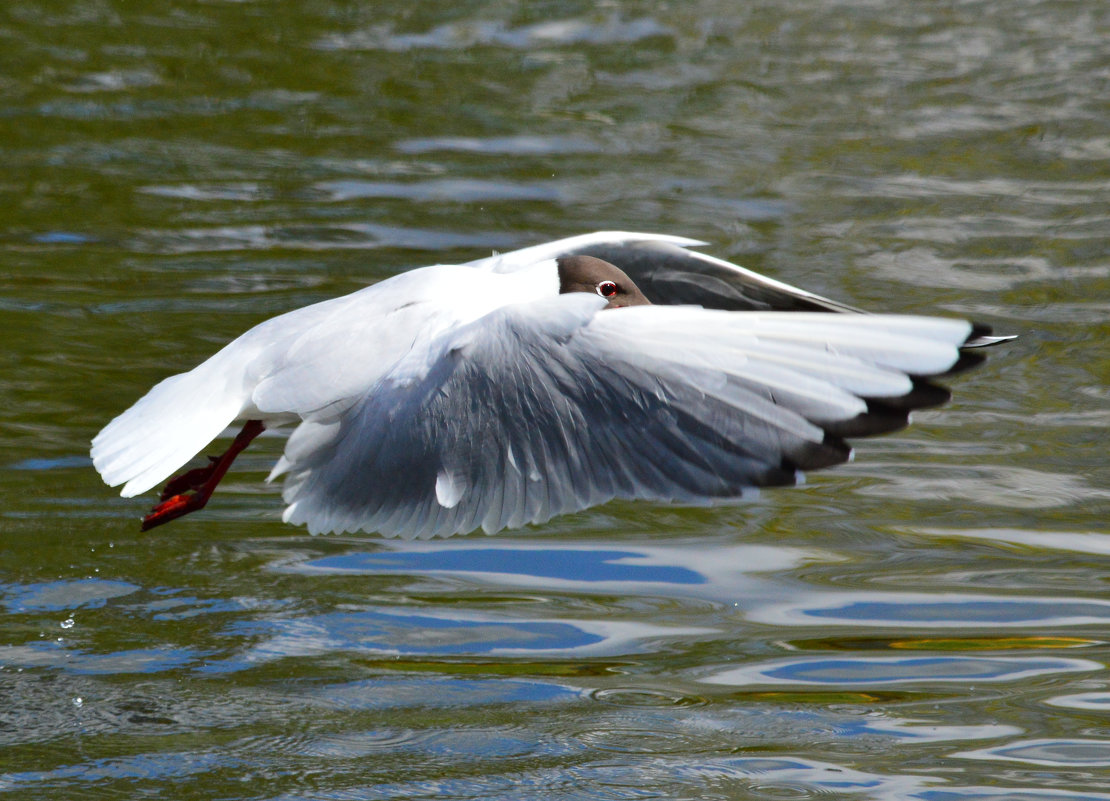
(275, 294), (970, 537)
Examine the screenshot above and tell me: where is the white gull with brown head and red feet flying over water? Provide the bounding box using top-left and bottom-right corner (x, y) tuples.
(92, 232), (1013, 538)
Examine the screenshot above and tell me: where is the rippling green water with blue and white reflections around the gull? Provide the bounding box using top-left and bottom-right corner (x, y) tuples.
(0, 0), (1110, 801)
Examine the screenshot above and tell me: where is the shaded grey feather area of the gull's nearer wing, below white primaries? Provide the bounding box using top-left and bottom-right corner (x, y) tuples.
(275, 295), (849, 537)
